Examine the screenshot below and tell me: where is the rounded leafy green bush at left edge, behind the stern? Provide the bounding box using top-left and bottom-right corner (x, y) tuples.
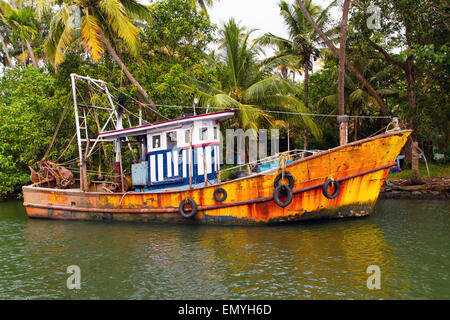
(0, 67), (65, 197)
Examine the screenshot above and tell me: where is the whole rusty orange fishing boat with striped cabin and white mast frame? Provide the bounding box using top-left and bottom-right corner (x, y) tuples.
(23, 74), (411, 224)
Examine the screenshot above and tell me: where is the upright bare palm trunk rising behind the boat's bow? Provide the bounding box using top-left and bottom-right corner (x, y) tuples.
(338, 0), (350, 146)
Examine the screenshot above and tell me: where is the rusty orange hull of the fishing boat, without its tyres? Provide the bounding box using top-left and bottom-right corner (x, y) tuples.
(23, 130), (411, 224)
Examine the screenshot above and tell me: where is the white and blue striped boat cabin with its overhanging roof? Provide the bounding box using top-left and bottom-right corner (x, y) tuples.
(100, 110), (234, 192)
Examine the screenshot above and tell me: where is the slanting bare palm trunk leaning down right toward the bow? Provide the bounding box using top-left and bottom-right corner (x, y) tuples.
(296, 0), (390, 115)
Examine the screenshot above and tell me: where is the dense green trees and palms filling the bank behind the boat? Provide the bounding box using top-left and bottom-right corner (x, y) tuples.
(0, 0), (450, 198)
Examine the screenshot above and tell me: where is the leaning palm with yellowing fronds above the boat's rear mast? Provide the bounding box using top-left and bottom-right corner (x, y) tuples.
(36, 0), (154, 105)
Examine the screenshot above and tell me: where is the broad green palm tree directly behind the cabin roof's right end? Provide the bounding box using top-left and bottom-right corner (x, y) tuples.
(193, 19), (321, 137)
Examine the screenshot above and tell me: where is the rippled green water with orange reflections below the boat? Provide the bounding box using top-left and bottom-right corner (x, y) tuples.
(0, 200), (450, 299)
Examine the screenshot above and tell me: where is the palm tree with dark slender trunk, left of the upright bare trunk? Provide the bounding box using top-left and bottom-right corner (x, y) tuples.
(258, 0), (336, 149)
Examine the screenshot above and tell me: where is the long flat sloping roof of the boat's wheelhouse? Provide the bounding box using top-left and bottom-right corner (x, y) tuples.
(99, 110), (235, 138)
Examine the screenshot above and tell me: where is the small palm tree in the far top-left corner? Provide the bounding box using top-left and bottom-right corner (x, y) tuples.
(0, 1), (38, 69)
